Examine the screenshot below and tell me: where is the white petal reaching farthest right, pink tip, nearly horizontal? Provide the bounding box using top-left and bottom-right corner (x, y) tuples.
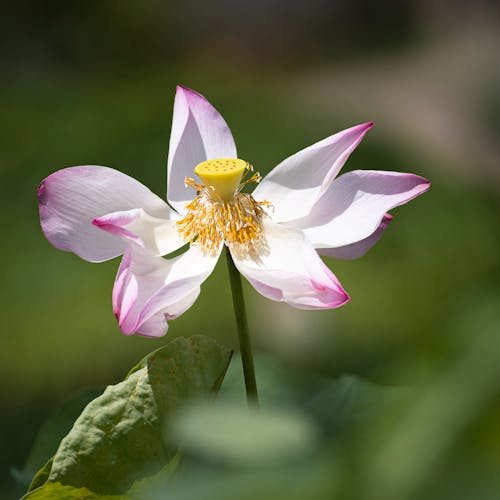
(289, 170), (430, 249)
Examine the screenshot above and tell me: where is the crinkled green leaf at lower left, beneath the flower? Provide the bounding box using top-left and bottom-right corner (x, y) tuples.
(26, 336), (231, 498)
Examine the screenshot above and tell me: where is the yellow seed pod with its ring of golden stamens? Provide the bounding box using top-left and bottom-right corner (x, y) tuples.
(177, 158), (270, 256)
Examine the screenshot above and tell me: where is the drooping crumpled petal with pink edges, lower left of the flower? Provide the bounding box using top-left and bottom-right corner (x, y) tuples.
(113, 244), (219, 337)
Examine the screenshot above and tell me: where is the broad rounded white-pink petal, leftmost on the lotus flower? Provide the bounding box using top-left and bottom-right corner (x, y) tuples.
(37, 166), (172, 262)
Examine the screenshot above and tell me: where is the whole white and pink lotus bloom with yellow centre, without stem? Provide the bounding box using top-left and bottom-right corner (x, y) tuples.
(38, 87), (429, 337)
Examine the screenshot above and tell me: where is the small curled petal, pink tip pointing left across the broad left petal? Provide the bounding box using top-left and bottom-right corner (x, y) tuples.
(92, 208), (185, 256)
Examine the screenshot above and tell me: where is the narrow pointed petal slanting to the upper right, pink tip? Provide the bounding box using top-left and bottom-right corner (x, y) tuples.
(253, 123), (373, 222)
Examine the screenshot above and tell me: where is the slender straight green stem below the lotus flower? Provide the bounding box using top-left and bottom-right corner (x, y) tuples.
(226, 247), (259, 408)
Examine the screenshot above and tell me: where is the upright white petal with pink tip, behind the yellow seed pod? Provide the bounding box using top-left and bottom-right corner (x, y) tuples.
(167, 86), (236, 213)
